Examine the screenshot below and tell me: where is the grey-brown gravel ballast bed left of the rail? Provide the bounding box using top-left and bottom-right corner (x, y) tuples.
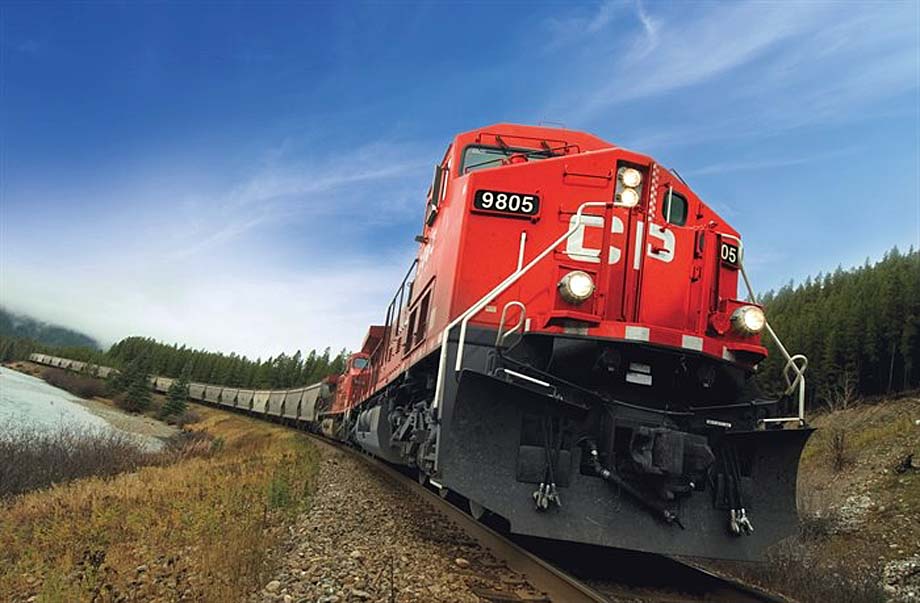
(250, 446), (546, 603)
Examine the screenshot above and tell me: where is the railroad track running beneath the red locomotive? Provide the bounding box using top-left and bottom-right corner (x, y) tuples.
(298, 430), (789, 603)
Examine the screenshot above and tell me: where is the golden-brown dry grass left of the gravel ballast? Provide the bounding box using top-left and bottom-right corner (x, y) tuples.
(0, 407), (317, 602)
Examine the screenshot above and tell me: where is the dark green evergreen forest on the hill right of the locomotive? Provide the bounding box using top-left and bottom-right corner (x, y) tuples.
(759, 247), (920, 406)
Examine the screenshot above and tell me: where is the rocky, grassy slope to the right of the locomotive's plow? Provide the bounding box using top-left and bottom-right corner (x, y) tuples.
(718, 392), (920, 603)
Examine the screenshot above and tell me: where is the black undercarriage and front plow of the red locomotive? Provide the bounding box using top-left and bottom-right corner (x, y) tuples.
(352, 330), (811, 559)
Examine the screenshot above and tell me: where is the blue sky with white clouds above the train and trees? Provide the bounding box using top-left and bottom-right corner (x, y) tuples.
(0, 0), (920, 358)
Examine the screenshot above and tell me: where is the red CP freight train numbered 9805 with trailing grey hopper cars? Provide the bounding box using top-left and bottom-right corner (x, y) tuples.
(32, 124), (812, 559)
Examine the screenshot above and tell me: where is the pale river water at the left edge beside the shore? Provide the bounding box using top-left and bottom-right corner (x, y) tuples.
(0, 367), (110, 429)
